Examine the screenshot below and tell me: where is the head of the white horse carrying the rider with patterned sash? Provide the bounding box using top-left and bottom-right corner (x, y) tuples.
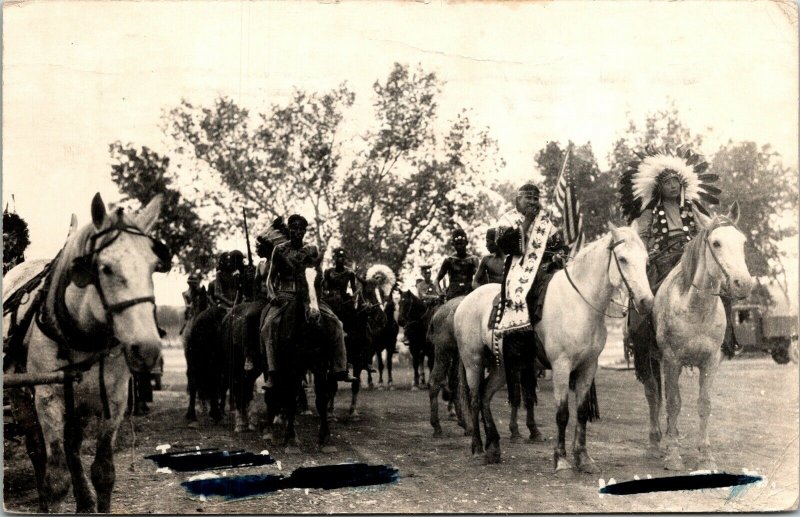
(608, 224), (653, 313)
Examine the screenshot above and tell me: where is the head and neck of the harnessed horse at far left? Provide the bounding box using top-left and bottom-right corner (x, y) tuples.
(65, 194), (172, 371)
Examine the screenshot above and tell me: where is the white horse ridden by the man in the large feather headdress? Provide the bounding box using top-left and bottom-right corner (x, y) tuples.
(644, 203), (753, 470)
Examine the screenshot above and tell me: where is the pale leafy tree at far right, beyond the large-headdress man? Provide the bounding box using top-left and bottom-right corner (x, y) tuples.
(711, 141), (798, 278)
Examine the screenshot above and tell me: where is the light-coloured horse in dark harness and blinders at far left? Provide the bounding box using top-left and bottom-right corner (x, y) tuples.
(7, 194), (170, 513)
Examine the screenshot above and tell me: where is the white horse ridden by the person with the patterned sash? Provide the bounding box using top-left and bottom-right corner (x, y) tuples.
(454, 227), (653, 475)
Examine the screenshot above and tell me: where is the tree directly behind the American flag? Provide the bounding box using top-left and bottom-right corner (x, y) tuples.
(535, 142), (619, 241)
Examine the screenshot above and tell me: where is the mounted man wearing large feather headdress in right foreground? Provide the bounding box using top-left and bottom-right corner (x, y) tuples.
(620, 146), (737, 355)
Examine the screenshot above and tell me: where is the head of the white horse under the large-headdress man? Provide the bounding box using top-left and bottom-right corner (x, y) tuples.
(685, 202), (754, 299)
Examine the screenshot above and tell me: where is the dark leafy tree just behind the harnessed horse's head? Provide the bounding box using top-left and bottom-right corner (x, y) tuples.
(109, 142), (221, 273)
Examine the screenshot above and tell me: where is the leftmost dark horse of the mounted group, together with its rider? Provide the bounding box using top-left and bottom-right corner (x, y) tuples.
(183, 252), (239, 422)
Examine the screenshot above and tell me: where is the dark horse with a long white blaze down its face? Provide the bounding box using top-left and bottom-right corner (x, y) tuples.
(261, 256), (341, 452)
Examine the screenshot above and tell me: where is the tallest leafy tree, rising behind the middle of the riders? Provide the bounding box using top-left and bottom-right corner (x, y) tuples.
(340, 63), (502, 271)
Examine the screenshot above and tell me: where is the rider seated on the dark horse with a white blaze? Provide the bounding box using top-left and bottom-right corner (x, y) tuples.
(261, 214), (356, 387)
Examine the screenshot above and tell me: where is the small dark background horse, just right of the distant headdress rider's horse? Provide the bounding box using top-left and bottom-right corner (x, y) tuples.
(397, 291), (437, 389)
